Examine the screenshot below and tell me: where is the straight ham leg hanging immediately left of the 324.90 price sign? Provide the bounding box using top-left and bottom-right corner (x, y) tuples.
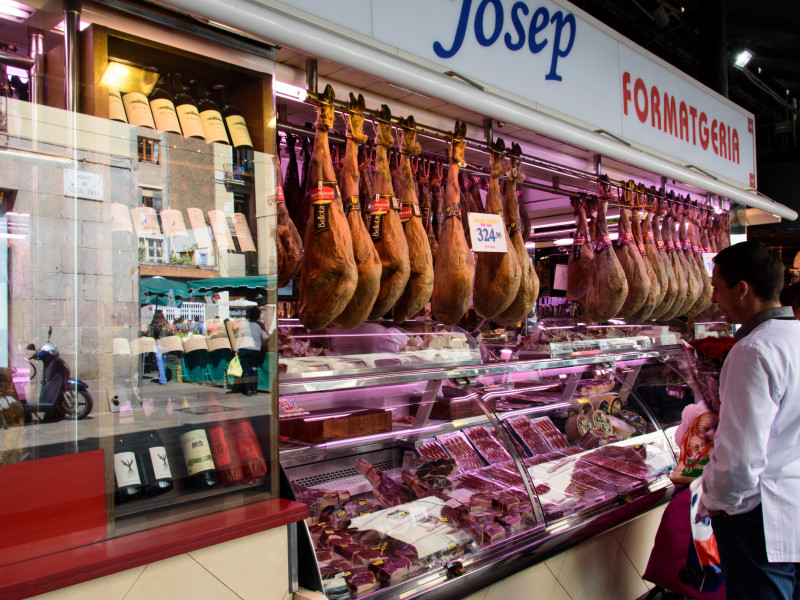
(431, 121), (475, 325)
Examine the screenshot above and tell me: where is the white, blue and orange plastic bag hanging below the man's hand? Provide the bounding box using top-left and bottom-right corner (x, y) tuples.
(686, 477), (723, 592)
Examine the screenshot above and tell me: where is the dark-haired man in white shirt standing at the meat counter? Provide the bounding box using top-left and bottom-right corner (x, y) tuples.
(702, 241), (800, 600)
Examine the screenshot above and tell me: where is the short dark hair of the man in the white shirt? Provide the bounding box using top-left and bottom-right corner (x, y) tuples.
(714, 240), (783, 302)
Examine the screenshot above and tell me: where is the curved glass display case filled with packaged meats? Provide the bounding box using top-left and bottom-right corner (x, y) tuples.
(280, 349), (691, 598)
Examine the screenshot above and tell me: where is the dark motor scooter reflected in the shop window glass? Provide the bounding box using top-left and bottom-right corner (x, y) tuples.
(23, 327), (94, 422)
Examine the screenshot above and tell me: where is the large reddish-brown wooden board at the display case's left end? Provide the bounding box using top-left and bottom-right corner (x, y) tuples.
(280, 406), (392, 443)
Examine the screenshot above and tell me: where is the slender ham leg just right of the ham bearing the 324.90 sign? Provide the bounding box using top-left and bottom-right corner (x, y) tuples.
(494, 144), (539, 325)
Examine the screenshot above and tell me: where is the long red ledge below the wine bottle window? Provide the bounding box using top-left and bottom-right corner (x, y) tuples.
(0, 499), (308, 600)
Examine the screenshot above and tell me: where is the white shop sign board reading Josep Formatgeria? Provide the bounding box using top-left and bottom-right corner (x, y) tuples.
(276, 0), (755, 187)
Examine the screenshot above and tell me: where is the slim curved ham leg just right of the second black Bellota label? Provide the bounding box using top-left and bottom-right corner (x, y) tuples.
(392, 117), (433, 323)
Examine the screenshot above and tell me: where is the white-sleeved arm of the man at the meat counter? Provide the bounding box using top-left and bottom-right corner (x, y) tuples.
(703, 342), (778, 512)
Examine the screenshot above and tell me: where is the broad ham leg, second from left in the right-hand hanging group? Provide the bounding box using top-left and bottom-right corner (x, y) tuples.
(586, 190), (628, 323)
